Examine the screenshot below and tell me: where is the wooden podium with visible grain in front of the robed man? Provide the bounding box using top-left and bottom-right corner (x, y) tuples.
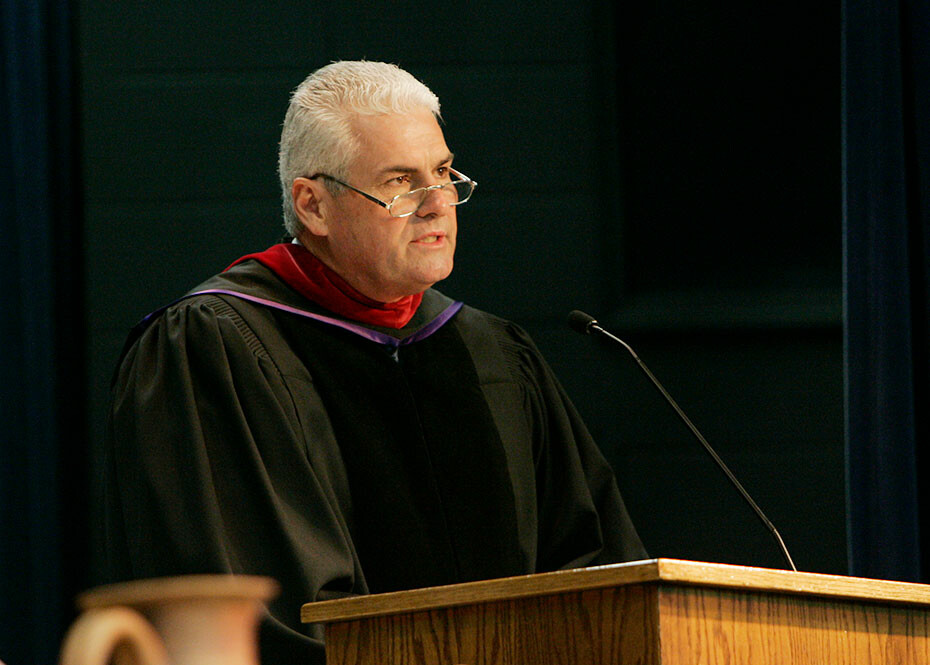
(301, 559), (930, 665)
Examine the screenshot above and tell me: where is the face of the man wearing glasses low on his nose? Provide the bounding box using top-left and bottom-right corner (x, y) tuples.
(327, 110), (456, 302)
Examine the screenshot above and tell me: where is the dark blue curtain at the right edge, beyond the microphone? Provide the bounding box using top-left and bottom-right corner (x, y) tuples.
(842, 0), (930, 581)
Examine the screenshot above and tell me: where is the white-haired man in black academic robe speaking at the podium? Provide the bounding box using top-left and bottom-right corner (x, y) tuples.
(99, 62), (645, 663)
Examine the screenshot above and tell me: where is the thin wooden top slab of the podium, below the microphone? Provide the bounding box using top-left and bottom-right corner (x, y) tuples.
(300, 559), (930, 623)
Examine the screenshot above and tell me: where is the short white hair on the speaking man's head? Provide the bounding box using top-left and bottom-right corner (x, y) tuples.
(278, 60), (440, 236)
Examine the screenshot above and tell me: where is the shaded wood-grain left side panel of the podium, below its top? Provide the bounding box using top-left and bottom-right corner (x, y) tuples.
(326, 586), (659, 665)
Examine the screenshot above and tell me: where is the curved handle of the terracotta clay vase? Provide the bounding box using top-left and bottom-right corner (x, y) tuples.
(59, 607), (169, 665)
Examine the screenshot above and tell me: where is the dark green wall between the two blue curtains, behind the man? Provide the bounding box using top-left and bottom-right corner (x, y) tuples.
(79, 0), (845, 572)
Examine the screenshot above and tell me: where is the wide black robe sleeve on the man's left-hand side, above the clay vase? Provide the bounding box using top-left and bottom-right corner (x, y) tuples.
(101, 296), (352, 664)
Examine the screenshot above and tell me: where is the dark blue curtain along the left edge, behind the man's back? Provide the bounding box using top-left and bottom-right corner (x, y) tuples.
(0, 0), (86, 665)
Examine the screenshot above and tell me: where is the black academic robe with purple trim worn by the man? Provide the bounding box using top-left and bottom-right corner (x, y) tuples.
(101, 260), (645, 665)
